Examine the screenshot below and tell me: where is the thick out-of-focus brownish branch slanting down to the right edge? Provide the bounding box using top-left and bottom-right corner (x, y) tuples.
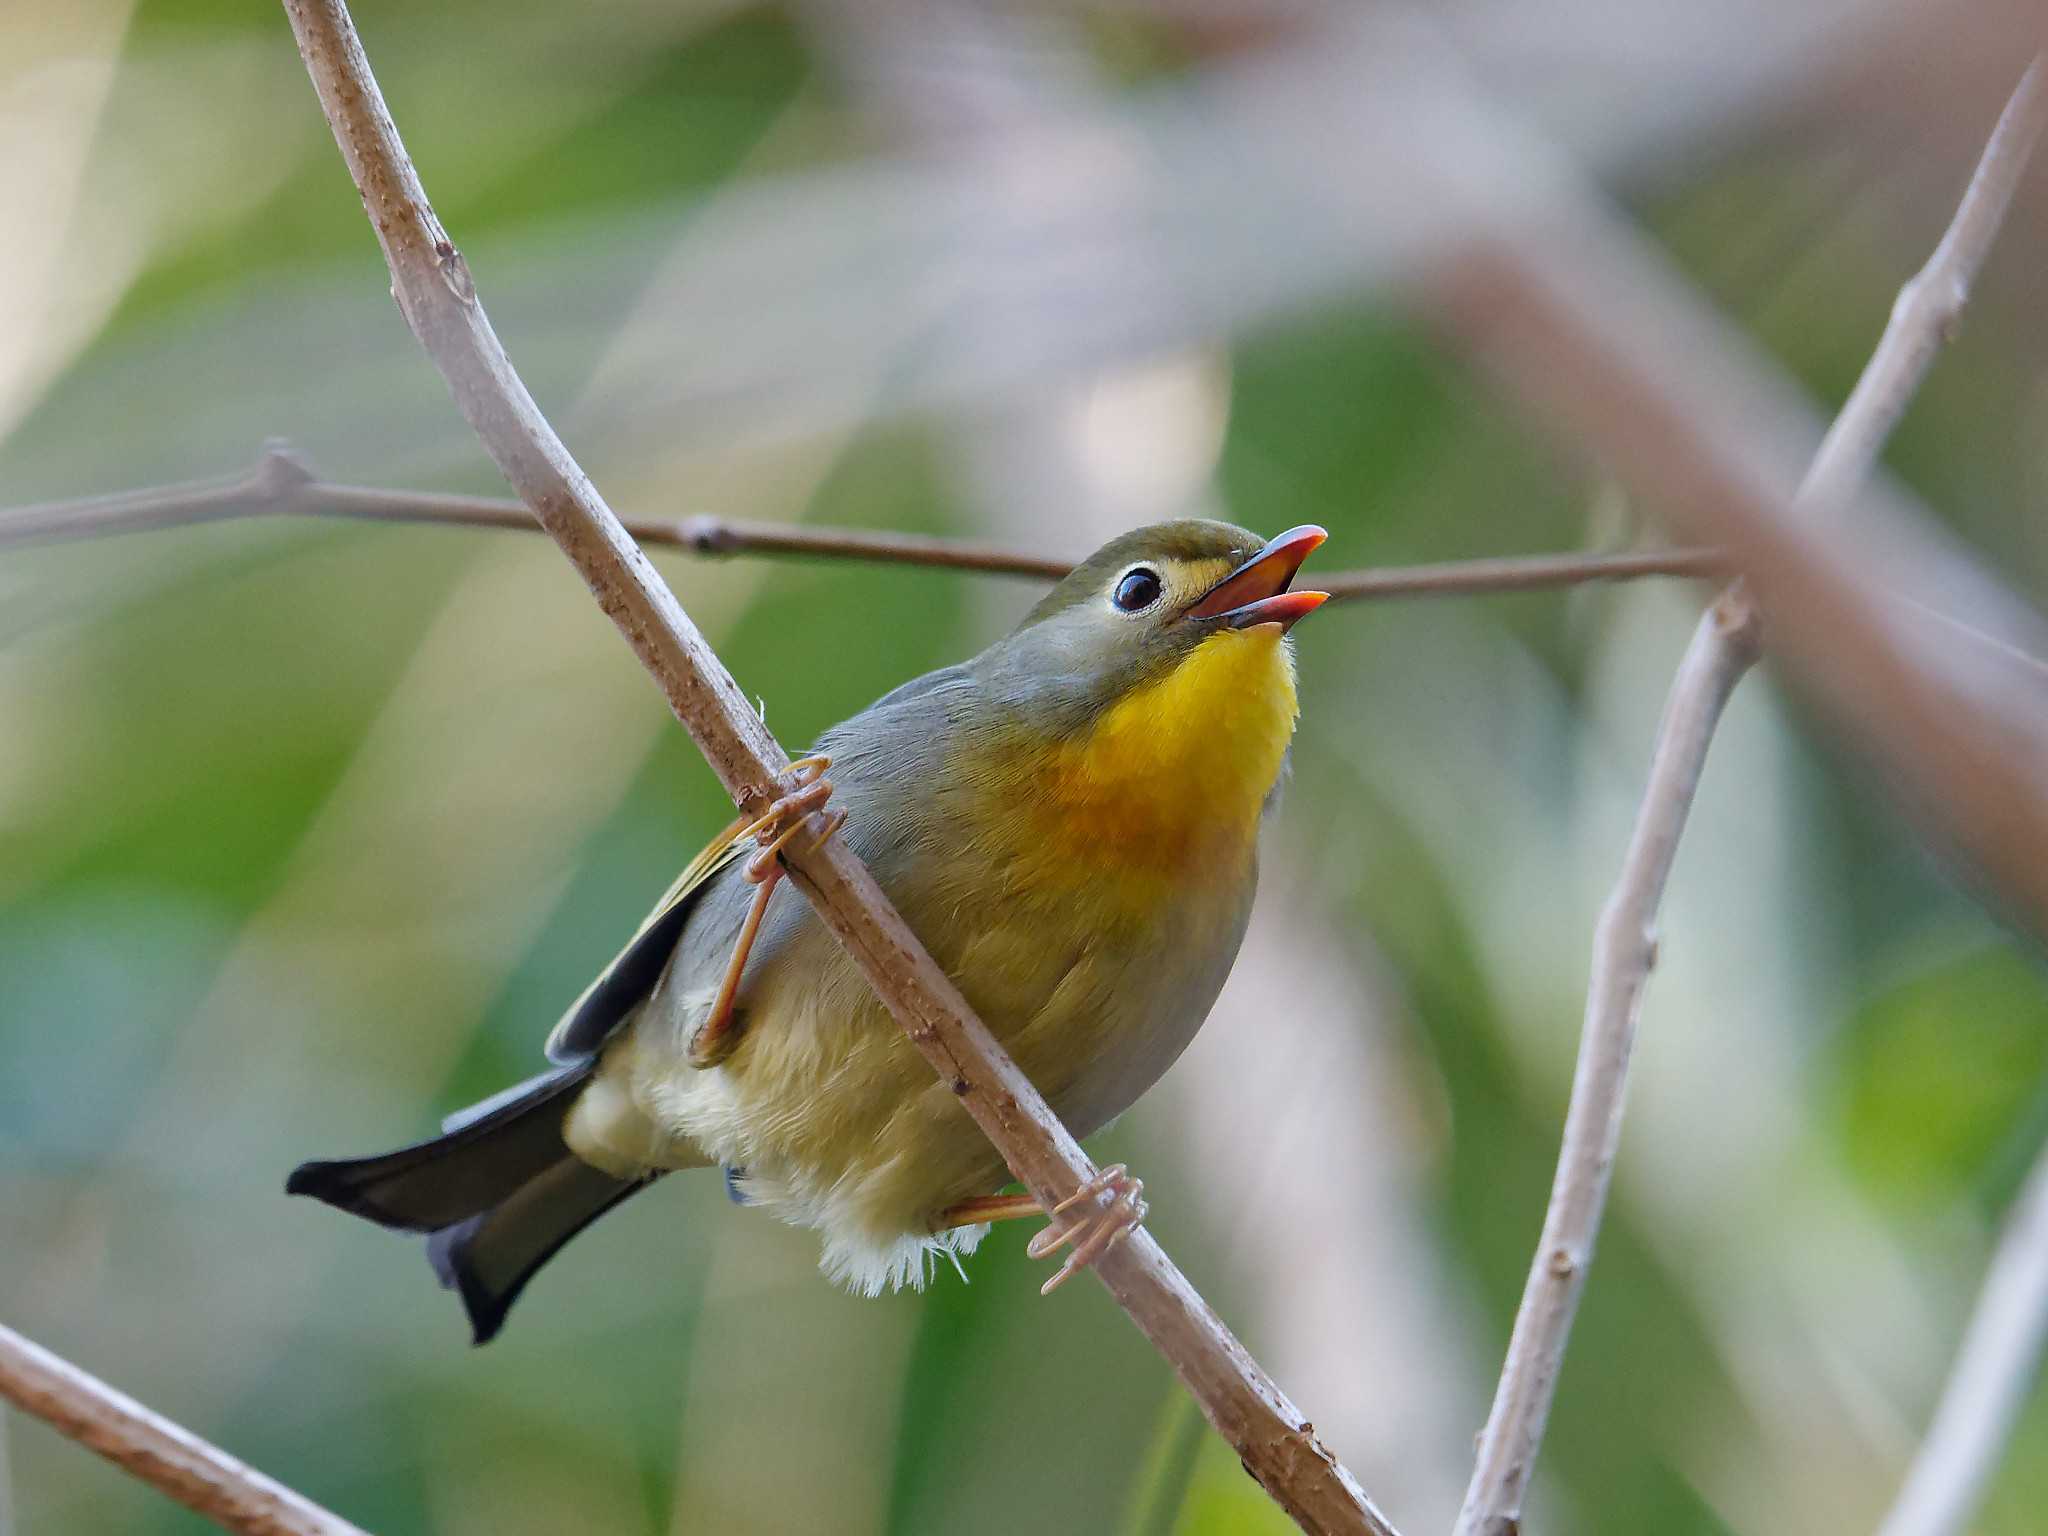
(1440, 99), (2048, 936)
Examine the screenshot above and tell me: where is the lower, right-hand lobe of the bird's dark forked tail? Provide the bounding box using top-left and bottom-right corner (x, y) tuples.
(426, 1151), (649, 1343)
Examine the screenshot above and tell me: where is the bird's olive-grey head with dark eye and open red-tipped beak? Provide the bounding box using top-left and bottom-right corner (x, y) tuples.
(973, 518), (1327, 733)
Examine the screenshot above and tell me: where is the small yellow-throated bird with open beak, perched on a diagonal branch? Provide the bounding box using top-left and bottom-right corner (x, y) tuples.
(296, 520), (1327, 1343)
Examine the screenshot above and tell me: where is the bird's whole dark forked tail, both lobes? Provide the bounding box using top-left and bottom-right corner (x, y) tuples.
(285, 1061), (643, 1343)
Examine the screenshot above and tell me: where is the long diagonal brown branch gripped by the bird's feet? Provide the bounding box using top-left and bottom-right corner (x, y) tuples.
(272, 0), (1393, 1536)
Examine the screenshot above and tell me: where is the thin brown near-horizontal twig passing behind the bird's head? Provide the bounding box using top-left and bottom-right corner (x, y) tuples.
(0, 442), (1729, 600)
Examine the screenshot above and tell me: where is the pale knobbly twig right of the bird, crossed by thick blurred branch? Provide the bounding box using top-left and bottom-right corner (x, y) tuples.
(1456, 51), (2048, 1536)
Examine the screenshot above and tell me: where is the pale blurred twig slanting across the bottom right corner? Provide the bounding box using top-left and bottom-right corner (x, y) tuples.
(1878, 1149), (2048, 1536)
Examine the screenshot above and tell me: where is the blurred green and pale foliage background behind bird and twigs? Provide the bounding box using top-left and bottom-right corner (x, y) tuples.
(0, 0), (2048, 1536)
